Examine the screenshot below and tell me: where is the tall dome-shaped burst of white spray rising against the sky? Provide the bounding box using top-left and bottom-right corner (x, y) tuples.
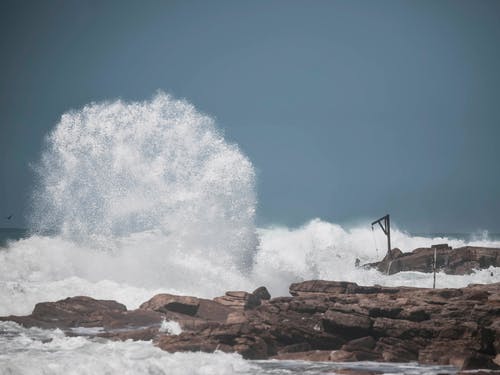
(31, 92), (256, 267)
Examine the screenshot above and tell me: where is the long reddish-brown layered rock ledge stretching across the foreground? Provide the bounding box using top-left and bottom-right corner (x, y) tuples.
(0, 280), (500, 370)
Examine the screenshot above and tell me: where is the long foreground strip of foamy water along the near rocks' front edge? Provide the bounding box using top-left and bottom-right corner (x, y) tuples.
(0, 322), (456, 375)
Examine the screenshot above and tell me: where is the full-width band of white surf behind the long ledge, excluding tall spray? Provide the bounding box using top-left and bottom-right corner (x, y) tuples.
(0, 220), (500, 315)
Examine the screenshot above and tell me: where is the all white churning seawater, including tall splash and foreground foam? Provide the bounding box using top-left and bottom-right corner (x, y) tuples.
(0, 93), (500, 374)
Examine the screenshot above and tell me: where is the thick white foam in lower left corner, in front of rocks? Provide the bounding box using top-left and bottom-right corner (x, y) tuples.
(0, 322), (256, 375)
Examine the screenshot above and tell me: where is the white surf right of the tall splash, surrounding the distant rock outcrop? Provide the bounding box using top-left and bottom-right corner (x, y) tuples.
(253, 219), (500, 295)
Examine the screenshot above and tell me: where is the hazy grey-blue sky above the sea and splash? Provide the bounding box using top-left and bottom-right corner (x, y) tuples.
(0, 0), (500, 232)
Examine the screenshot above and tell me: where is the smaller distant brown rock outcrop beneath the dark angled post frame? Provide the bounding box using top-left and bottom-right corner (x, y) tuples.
(366, 244), (500, 275)
